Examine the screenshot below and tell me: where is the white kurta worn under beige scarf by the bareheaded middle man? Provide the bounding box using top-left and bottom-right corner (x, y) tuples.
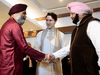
(34, 30), (66, 75)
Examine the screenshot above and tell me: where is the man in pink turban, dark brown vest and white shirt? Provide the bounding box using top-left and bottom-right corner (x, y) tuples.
(49, 2), (100, 75)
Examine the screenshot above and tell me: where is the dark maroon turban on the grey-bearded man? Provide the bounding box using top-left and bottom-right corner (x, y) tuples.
(8, 4), (27, 16)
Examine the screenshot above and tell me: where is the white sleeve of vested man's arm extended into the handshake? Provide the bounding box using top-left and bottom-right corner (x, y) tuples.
(53, 43), (70, 58)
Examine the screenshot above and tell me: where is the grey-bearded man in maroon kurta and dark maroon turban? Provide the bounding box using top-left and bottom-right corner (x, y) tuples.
(0, 4), (45, 75)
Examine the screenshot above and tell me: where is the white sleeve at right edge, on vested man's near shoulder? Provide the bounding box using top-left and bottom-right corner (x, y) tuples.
(87, 21), (100, 66)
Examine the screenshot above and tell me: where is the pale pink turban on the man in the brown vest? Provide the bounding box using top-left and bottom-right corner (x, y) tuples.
(67, 2), (93, 14)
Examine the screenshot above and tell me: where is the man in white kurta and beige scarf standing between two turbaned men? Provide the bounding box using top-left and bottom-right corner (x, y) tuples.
(34, 13), (66, 75)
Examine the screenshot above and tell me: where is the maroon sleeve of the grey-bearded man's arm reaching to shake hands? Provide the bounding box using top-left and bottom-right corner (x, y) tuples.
(11, 18), (45, 61)
